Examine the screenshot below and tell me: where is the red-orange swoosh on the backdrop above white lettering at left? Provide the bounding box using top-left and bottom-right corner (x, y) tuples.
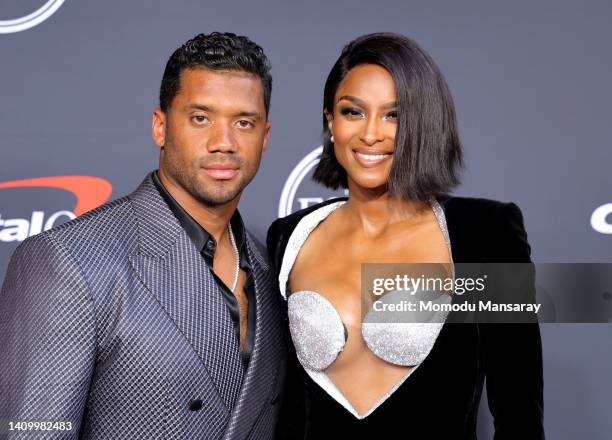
(0, 176), (113, 215)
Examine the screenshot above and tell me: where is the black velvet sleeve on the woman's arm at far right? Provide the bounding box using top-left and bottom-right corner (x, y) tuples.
(479, 203), (544, 440)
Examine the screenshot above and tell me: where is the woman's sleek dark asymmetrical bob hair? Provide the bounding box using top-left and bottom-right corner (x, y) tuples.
(313, 33), (463, 200)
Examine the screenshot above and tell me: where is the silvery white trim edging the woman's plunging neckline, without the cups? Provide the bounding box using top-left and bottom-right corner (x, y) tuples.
(278, 197), (455, 420)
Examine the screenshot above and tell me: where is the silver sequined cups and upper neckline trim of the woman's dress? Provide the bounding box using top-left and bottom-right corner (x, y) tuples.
(279, 198), (450, 384)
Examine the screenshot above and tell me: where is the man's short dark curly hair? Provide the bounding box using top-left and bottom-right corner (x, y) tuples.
(159, 32), (272, 115)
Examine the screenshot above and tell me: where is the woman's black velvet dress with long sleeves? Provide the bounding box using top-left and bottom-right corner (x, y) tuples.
(267, 196), (544, 440)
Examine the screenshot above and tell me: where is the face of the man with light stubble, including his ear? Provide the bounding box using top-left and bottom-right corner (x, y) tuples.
(153, 68), (270, 206)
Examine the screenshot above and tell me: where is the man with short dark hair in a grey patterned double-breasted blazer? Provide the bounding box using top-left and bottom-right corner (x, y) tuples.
(0, 33), (285, 439)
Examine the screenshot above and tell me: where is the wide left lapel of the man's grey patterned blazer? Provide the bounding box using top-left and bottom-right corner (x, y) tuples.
(130, 174), (244, 415)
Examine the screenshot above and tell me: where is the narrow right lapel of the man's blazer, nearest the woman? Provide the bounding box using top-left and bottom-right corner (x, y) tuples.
(225, 234), (284, 439)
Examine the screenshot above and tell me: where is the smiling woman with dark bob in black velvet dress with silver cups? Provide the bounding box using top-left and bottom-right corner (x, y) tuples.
(268, 33), (544, 439)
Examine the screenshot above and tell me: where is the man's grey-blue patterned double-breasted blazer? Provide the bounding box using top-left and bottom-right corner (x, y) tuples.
(0, 175), (286, 440)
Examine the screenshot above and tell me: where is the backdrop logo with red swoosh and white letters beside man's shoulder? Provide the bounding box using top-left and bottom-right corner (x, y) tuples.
(0, 176), (113, 242)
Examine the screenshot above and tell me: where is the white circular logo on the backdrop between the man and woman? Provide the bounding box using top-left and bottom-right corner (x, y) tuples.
(278, 146), (348, 217)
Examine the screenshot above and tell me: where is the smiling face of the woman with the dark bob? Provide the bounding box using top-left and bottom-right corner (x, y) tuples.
(326, 64), (397, 190)
